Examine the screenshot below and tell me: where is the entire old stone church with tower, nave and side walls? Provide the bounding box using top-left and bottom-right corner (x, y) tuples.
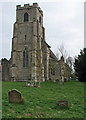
(2, 3), (70, 82)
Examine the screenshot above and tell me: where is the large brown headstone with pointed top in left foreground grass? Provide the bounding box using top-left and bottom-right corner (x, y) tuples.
(8, 89), (22, 103)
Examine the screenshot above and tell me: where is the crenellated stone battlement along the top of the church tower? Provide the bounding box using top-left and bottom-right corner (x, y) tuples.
(16, 3), (43, 14)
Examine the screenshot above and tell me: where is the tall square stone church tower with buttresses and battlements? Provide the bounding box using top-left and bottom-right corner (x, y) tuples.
(10, 3), (49, 81)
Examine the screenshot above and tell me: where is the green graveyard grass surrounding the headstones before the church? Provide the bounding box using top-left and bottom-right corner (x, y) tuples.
(2, 81), (84, 118)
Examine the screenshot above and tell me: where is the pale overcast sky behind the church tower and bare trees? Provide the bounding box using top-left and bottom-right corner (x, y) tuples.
(0, 1), (84, 59)
